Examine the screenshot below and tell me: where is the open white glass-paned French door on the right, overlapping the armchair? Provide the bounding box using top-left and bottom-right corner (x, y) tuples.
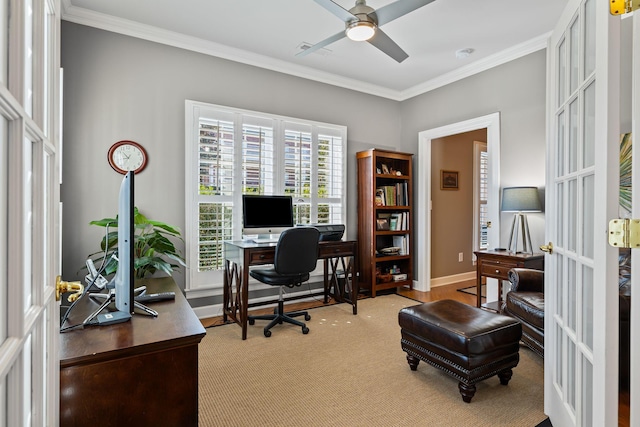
(544, 0), (620, 427)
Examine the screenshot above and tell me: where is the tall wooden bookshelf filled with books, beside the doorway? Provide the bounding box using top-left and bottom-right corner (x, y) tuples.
(356, 149), (413, 297)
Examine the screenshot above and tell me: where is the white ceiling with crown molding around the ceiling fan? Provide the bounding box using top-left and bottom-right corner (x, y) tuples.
(62, 0), (568, 100)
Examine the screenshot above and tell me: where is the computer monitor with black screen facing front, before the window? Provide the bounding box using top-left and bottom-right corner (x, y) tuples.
(242, 194), (293, 236)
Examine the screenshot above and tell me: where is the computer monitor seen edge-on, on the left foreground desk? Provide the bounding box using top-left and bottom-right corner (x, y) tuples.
(107, 171), (135, 313)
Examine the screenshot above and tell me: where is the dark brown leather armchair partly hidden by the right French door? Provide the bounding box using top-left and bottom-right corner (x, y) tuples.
(501, 268), (544, 357)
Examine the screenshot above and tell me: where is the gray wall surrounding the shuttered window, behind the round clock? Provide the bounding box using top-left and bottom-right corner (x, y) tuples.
(61, 22), (400, 287)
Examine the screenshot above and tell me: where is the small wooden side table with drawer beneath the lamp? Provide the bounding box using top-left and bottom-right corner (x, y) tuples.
(474, 251), (544, 312)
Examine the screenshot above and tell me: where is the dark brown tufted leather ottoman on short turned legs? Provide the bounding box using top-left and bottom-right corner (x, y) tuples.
(398, 300), (522, 403)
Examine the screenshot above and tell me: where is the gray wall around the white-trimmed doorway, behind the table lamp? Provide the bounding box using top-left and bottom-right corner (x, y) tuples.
(399, 51), (546, 275)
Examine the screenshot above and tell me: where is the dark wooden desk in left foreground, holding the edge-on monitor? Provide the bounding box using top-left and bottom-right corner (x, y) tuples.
(60, 277), (206, 427)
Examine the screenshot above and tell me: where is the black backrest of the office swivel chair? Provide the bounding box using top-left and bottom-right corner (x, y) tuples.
(273, 227), (320, 274)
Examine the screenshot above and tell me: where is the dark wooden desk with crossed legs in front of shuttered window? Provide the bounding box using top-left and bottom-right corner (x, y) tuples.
(222, 240), (359, 340)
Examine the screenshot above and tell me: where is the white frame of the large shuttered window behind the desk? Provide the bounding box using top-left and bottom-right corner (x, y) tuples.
(184, 100), (347, 297)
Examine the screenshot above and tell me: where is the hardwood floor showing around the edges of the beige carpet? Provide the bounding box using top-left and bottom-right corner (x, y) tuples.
(200, 279), (629, 427)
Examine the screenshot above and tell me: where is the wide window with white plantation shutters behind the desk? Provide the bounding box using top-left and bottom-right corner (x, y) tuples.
(185, 101), (347, 291)
